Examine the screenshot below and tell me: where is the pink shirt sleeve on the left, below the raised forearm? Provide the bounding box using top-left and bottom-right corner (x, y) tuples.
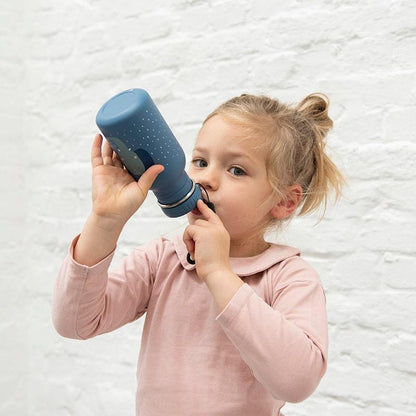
(52, 237), (158, 339)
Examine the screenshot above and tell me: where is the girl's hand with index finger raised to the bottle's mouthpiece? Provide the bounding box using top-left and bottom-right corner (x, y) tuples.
(183, 200), (231, 281)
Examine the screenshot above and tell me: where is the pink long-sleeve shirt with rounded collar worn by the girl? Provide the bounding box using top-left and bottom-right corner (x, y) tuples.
(53, 237), (327, 416)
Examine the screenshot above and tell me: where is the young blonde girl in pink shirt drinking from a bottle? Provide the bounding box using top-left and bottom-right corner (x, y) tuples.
(53, 94), (342, 416)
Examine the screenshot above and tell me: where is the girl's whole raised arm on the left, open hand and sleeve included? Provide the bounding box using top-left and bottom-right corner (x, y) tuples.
(53, 135), (163, 338)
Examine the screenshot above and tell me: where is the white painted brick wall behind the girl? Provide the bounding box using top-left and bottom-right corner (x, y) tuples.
(0, 0), (416, 416)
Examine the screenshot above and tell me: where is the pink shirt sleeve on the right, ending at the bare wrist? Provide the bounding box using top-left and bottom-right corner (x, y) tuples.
(217, 281), (327, 402)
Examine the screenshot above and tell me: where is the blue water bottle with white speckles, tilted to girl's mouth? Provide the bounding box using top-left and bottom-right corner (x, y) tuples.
(96, 89), (202, 218)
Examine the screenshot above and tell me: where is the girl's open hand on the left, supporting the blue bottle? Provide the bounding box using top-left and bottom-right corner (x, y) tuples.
(91, 134), (164, 225)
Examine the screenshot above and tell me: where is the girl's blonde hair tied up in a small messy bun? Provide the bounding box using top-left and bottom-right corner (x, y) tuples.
(204, 93), (344, 219)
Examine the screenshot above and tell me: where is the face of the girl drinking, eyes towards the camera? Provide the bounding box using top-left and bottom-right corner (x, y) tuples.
(188, 115), (278, 250)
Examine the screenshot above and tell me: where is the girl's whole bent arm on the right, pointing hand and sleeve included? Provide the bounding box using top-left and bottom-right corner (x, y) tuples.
(184, 202), (327, 402)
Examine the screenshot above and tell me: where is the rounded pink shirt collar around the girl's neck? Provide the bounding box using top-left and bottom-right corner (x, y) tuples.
(173, 235), (300, 277)
